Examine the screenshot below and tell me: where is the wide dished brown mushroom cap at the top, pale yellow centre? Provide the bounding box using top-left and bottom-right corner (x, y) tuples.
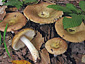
(24, 2), (63, 24)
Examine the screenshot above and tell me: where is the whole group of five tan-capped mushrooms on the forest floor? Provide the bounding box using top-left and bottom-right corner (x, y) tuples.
(0, 2), (85, 62)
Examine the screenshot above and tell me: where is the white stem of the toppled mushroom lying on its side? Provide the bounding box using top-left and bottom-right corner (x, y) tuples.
(20, 36), (40, 62)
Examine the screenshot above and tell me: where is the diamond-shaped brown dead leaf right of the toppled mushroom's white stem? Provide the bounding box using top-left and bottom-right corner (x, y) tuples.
(31, 31), (44, 51)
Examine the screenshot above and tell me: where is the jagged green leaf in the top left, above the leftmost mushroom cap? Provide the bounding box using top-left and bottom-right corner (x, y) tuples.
(4, 0), (23, 9)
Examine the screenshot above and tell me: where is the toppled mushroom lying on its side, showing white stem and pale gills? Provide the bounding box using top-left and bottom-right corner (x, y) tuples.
(12, 28), (40, 62)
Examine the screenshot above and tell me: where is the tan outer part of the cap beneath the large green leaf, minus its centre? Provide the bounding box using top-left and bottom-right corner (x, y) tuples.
(55, 17), (85, 43)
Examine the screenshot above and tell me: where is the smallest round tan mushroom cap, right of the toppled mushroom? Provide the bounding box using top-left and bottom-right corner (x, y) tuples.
(45, 38), (68, 55)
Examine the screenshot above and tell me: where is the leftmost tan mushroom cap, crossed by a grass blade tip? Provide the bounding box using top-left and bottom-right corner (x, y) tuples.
(0, 12), (27, 32)
